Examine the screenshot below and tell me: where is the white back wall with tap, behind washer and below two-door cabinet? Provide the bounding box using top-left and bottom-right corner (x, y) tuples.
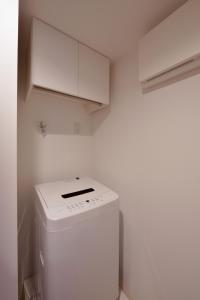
(18, 93), (92, 292)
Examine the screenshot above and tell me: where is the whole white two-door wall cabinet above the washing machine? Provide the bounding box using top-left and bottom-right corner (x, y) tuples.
(27, 19), (110, 110)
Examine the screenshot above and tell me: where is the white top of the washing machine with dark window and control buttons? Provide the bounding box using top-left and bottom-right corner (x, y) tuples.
(35, 178), (118, 230)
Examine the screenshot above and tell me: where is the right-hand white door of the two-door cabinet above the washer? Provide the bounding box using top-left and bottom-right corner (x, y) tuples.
(78, 43), (110, 104)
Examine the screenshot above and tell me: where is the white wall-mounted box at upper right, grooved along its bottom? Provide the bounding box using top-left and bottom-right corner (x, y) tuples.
(139, 0), (200, 92)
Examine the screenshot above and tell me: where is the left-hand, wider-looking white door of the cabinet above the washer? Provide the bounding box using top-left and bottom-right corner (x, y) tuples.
(31, 19), (78, 95)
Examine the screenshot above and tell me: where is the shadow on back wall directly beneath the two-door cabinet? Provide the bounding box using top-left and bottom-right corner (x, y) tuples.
(24, 91), (91, 136)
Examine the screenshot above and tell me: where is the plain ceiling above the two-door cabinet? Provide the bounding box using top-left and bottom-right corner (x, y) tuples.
(20, 0), (186, 60)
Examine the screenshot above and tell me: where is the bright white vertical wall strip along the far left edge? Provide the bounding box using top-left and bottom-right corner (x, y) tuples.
(0, 0), (18, 300)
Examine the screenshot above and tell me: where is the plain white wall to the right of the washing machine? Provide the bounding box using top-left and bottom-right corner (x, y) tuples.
(93, 51), (200, 300)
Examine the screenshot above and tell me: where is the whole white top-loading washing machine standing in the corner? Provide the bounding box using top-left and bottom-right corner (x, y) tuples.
(35, 178), (119, 300)
